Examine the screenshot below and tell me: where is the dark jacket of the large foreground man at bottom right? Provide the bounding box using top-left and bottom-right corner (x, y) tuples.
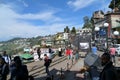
(100, 62), (118, 80)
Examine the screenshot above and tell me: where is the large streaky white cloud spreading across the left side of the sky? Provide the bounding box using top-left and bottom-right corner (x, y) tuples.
(0, 4), (71, 41)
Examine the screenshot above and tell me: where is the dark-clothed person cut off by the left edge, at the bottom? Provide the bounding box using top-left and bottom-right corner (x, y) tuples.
(0, 57), (9, 80)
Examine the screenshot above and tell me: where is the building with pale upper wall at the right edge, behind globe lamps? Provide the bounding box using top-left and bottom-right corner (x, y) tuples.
(105, 12), (120, 43)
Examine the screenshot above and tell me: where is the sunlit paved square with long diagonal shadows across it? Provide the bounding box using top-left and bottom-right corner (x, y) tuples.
(27, 52), (83, 80)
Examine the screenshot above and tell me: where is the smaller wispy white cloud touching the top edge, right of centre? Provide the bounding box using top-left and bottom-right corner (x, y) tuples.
(67, 0), (95, 11)
